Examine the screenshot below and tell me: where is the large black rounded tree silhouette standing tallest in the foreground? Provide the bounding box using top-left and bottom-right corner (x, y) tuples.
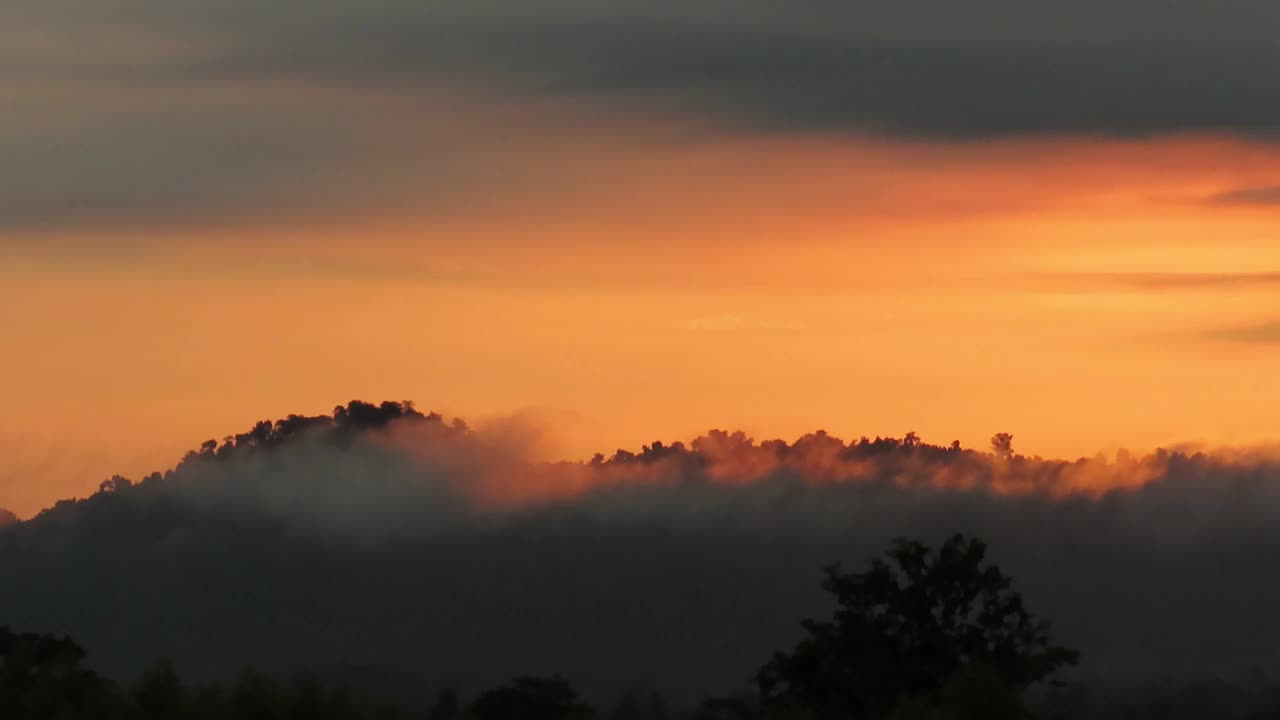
(756, 534), (1076, 720)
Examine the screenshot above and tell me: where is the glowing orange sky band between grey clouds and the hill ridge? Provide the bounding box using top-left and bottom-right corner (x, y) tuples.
(0, 128), (1280, 515)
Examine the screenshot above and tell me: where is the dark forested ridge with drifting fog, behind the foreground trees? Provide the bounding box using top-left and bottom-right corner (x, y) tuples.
(0, 402), (1280, 691)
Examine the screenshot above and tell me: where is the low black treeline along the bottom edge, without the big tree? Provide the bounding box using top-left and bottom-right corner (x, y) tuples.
(0, 638), (1280, 720)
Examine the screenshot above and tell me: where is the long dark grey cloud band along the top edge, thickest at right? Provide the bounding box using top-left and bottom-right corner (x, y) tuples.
(45, 0), (1280, 137)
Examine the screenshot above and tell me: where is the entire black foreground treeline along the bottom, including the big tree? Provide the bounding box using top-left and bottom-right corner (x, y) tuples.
(0, 536), (1280, 720)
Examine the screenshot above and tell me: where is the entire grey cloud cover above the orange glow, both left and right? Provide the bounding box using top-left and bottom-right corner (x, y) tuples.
(0, 0), (1280, 229)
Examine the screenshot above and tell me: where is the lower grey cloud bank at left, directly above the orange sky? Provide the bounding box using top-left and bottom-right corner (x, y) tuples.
(0, 83), (514, 230)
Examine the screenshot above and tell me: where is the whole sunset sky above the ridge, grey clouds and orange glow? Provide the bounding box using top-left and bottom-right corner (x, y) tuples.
(0, 0), (1280, 515)
